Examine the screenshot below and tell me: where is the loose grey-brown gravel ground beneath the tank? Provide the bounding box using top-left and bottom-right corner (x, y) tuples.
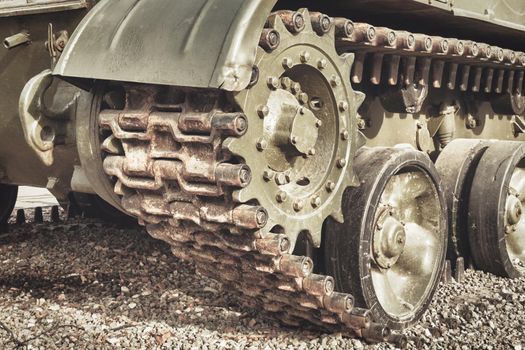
(0, 209), (525, 350)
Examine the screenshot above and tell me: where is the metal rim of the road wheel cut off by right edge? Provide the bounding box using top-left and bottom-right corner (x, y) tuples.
(505, 164), (525, 273)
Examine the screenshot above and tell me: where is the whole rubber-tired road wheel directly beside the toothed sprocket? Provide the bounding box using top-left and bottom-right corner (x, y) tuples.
(323, 148), (447, 329)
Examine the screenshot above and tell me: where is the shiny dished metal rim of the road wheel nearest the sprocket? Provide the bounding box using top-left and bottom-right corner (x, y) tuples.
(370, 167), (442, 319)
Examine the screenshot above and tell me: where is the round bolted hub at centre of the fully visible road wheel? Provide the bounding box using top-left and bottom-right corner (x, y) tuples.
(373, 208), (406, 269)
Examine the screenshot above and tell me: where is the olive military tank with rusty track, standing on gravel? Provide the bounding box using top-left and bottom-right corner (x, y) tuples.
(0, 0), (525, 344)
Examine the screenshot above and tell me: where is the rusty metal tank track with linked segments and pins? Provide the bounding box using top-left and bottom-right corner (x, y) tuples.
(93, 9), (525, 344)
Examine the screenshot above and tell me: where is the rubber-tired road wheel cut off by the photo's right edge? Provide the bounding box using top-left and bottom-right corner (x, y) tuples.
(469, 141), (525, 278)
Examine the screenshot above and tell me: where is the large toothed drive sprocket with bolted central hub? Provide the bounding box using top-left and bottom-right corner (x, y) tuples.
(224, 10), (363, 250)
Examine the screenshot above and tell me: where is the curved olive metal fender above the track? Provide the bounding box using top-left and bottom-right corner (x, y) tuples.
(53, 0), (277, 91)
